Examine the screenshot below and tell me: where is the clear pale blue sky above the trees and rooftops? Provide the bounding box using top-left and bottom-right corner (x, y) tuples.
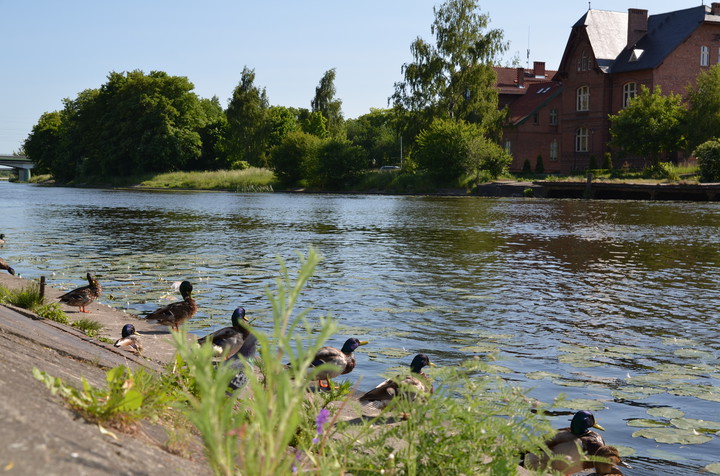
(0, 0), (709, 154)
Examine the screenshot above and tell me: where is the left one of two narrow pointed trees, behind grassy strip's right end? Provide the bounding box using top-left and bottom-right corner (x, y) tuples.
(225, 66), (269, 167)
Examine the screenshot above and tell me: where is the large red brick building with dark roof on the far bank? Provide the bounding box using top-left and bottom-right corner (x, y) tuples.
(498, 3), (720, 174)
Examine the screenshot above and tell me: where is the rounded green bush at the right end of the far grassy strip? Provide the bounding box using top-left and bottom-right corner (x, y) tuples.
(270, 131), (322, 187)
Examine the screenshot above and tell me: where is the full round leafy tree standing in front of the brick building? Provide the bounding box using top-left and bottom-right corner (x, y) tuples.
(610, 86), (685, 168)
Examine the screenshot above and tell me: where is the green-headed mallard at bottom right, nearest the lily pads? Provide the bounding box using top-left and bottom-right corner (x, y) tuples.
(525, 410), (605, 474)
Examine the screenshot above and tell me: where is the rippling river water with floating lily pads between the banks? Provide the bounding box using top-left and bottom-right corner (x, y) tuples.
(0, 182), (720, 475)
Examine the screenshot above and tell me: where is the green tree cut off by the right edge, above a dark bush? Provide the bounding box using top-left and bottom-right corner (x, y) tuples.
(685, 65), (720, 150)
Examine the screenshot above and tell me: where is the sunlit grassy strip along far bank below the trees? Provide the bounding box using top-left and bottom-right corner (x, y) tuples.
(140, 167), (275, 192)
